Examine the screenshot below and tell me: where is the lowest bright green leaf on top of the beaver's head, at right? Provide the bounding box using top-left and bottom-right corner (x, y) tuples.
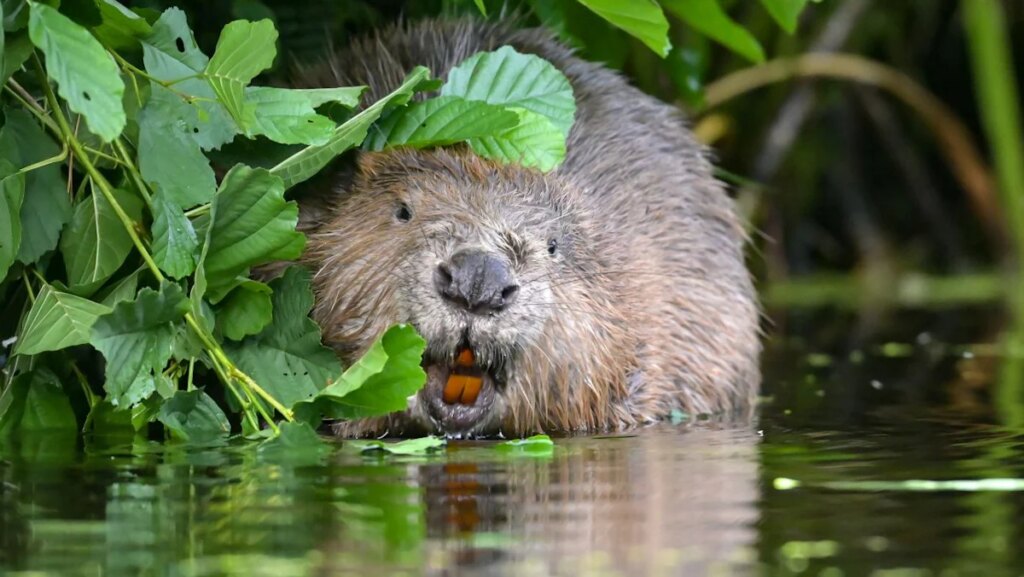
(469, 109), (565, 172)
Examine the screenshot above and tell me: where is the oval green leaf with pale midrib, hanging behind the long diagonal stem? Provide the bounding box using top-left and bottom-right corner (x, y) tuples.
(60, 187), (142, 296)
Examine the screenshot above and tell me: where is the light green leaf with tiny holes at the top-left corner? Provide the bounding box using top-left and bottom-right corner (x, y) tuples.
(29, 2), (126, 142)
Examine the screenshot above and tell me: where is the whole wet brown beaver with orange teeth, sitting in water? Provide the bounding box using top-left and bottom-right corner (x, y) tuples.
(297, 19), (760, 438)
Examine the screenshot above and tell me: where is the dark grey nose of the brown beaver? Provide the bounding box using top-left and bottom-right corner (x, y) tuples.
(434, 250), (519, 315)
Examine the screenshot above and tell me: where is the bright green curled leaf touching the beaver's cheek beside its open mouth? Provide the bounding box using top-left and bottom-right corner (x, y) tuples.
(294, 325), (427, 421)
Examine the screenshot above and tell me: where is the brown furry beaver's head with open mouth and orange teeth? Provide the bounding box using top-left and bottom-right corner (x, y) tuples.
(304, 149), (633, 437)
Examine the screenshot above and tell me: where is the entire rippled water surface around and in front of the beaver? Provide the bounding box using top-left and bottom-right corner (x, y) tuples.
(0, 311), (1024, 577)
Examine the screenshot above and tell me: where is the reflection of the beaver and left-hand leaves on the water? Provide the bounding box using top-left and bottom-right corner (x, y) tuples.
(0, 423), (758, 576)
